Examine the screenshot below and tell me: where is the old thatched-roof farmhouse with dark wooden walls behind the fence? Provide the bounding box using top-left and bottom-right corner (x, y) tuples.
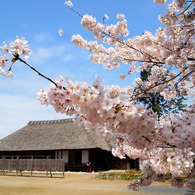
(0, 119), (139, 171)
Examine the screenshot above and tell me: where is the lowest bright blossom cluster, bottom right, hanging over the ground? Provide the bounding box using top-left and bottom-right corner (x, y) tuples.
(112, 133), (195, 190)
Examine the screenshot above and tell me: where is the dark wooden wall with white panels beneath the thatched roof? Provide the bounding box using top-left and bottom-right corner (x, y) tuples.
(0, 148), (139, 171)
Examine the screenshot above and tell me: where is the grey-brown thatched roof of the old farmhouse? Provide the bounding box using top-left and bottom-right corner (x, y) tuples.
(0, 119), (110, 151)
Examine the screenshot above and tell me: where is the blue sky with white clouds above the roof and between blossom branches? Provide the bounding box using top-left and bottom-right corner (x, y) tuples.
(0, 0), (169, 139)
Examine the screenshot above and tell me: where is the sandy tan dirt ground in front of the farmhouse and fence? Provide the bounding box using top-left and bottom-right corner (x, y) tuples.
(0, 173), (193, 195)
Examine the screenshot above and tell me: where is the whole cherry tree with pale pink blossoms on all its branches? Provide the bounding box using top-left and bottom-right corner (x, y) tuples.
(0, 0), (195, 190)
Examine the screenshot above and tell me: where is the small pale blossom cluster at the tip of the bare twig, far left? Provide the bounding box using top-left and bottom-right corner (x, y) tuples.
(0, 37), (32, 77)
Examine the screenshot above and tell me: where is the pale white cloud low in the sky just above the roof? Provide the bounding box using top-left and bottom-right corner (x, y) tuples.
(0, 94), (67, 139)
